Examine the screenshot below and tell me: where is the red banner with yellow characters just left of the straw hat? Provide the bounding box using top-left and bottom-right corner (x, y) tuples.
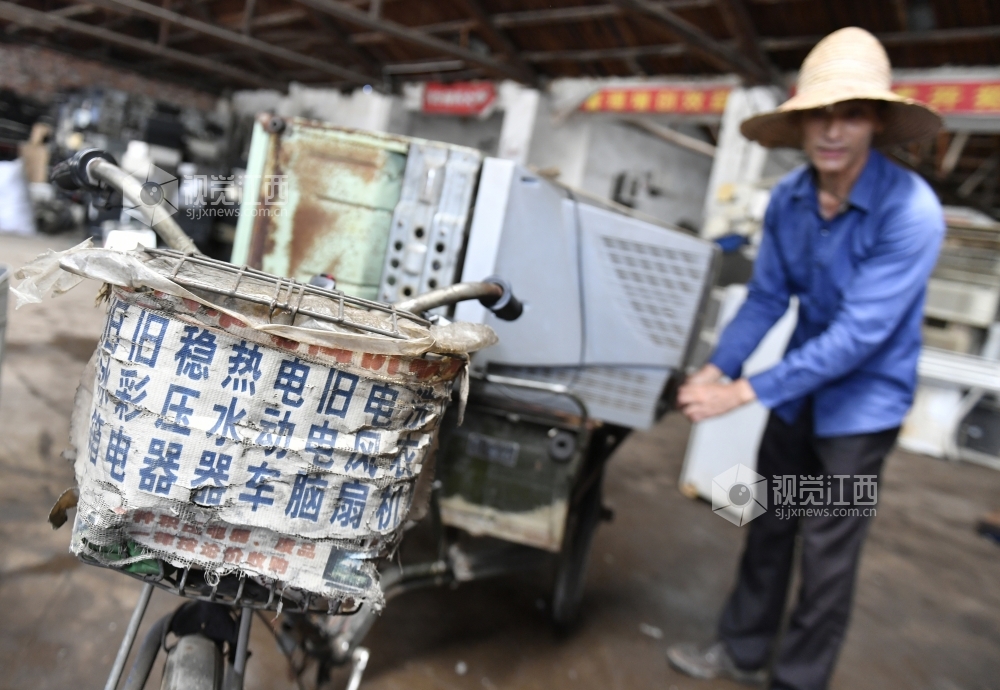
(580, 85), (730, 115)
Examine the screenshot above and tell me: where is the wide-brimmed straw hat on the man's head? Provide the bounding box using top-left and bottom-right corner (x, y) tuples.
(740, 27), (941, 148)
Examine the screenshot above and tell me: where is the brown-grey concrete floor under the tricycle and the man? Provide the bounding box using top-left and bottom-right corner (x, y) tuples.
(0, 236), (1000, 690)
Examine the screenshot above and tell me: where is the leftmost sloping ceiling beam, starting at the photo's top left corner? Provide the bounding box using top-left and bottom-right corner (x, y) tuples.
(0, 0), (283, 88)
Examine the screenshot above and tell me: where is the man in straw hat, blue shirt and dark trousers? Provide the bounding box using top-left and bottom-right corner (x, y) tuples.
(668, 28), (944, 690)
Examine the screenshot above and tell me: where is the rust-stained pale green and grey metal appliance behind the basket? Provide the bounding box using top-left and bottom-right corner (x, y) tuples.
(232, 115), (482, 302)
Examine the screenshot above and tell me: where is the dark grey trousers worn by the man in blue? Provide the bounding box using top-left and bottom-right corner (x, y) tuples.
(719, 405), (899, 690)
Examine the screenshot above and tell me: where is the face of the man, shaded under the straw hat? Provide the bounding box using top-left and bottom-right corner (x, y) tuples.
(802, 101), (882, 174)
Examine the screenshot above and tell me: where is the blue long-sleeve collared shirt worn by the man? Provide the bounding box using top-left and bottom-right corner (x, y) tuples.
(711, 151), (944, 436)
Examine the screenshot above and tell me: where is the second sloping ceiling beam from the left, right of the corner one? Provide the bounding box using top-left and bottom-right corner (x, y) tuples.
(66, 0), (371, 84)
